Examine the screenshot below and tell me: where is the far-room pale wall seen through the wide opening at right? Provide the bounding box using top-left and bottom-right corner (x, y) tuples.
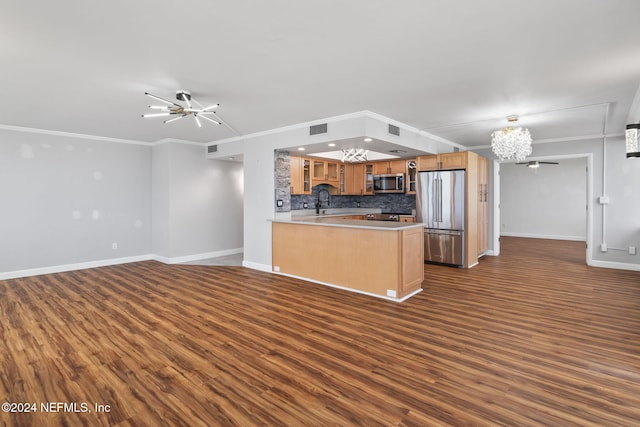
(500, 158), (587, 240)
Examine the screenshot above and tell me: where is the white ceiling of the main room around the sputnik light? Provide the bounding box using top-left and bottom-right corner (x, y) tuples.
(0, 0), (640, 155)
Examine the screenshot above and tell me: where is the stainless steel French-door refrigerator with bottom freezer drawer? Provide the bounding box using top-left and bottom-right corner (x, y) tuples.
(416, 170), (466, 267)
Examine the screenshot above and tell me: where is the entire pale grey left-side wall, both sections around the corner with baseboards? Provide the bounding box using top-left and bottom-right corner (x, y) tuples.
(0, 129), (244, 279)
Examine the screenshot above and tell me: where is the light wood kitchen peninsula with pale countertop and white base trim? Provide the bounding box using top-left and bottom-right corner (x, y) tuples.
(272, 214), (424, 301)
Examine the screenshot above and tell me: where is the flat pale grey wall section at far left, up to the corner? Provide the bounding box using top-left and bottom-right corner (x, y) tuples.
(0, 130), (151, 273)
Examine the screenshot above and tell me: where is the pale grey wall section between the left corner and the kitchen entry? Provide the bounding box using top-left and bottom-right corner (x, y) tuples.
(153, 143), (244, 262)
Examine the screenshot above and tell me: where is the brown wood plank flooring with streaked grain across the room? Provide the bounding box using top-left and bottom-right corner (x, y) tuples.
(0, 238), (640, 426)
